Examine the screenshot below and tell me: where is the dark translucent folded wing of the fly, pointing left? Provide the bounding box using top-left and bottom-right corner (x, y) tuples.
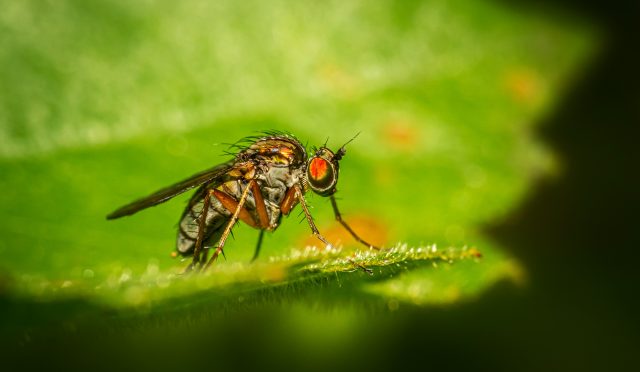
(107, 162), (239, 220)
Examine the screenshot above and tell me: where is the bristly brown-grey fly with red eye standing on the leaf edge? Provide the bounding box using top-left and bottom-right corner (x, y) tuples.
(107, 132), (378, 271)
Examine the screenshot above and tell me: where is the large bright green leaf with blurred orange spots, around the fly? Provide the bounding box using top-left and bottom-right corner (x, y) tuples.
(0, 0), (636, 365)
